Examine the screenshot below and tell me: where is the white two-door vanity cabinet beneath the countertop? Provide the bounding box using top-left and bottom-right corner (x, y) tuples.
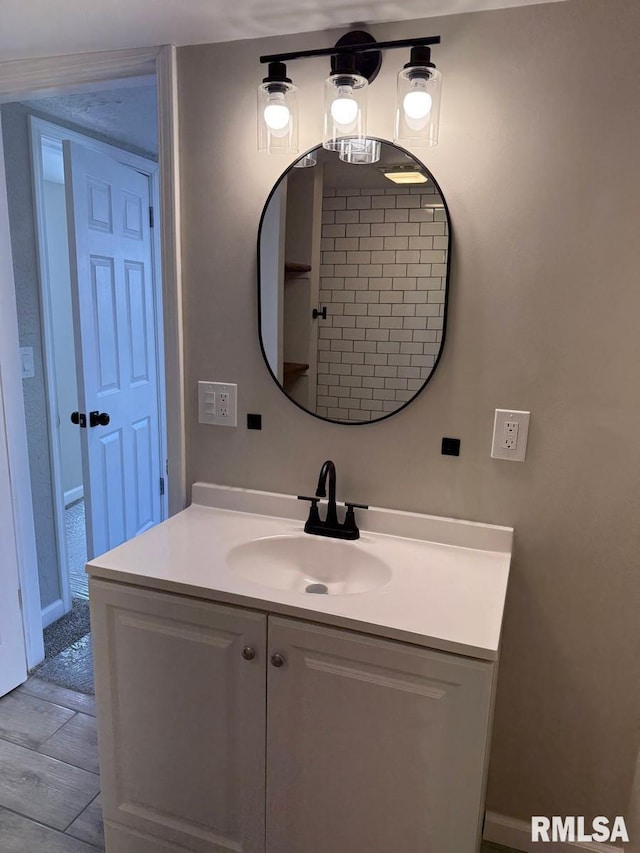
(90, 578), (494, 853)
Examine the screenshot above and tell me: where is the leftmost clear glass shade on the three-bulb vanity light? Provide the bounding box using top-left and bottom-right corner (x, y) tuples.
(258, 83), (298, 154)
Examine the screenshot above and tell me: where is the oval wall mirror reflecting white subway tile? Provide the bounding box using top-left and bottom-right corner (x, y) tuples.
(258, 140), (451, 424)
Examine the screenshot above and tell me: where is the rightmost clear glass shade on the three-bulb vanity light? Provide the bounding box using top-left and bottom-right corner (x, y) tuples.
(394, 67), (442, 148)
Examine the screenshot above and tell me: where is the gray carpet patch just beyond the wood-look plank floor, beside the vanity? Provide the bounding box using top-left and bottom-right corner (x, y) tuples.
(33, 598), (94, 695)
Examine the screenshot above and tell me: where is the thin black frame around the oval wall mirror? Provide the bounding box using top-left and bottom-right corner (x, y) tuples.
(256, 136), (453, 427)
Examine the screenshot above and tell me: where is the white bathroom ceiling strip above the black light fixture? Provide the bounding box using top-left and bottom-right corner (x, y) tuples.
(0, 0), (563, 61)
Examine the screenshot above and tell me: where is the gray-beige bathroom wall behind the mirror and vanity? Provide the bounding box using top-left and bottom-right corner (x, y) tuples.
(178, 0), (640, 820)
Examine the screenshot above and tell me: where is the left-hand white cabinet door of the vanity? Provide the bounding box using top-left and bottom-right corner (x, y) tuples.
(90, 580), (266, 853)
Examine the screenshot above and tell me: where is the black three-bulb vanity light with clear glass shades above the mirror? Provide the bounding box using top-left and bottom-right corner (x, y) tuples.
(258, 30), (442, 156)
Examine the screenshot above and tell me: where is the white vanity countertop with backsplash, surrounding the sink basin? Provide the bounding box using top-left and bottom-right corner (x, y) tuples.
(87, 484), (513, 660)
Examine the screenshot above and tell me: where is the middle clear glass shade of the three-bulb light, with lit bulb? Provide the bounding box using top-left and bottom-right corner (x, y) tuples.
(322, 74), (369, 151)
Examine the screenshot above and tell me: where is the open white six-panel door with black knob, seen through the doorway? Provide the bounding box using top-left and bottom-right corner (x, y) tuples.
(63, 141), (162, 559)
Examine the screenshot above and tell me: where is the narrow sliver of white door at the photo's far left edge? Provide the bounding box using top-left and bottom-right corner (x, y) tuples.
(0, 364), (27, 696)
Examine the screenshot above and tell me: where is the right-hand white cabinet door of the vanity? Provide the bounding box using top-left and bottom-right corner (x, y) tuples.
(267, 617), (492, 853)
